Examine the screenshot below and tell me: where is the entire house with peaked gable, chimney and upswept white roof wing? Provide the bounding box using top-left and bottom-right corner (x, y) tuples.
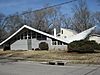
(0, 25), (95, 50)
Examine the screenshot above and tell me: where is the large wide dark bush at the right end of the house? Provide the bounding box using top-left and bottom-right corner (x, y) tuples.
(68, 40), (100, 53)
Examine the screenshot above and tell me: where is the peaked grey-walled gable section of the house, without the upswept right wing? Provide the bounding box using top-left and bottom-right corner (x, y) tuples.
(0, 25), (67, 50)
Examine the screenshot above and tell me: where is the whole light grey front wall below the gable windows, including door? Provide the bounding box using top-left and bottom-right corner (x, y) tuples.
(11, 38), (67, 50)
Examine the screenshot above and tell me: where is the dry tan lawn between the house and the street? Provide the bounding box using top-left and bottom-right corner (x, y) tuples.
(0, 51), (100, 64)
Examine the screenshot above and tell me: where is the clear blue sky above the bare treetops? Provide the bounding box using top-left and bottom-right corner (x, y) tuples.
(0, 0), (100, 15)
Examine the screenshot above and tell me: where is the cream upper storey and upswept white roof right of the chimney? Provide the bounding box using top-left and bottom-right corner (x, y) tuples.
(57, 26), (96, 43)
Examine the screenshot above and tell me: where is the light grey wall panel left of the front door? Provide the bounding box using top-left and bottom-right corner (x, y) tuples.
(10, 39), (28, 50)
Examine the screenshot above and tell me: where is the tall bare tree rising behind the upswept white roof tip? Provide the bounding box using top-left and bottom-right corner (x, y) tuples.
(72, 0), (95, 32)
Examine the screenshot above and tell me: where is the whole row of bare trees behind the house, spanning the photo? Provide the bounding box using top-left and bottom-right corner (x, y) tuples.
(0, 0), (100, 42)
